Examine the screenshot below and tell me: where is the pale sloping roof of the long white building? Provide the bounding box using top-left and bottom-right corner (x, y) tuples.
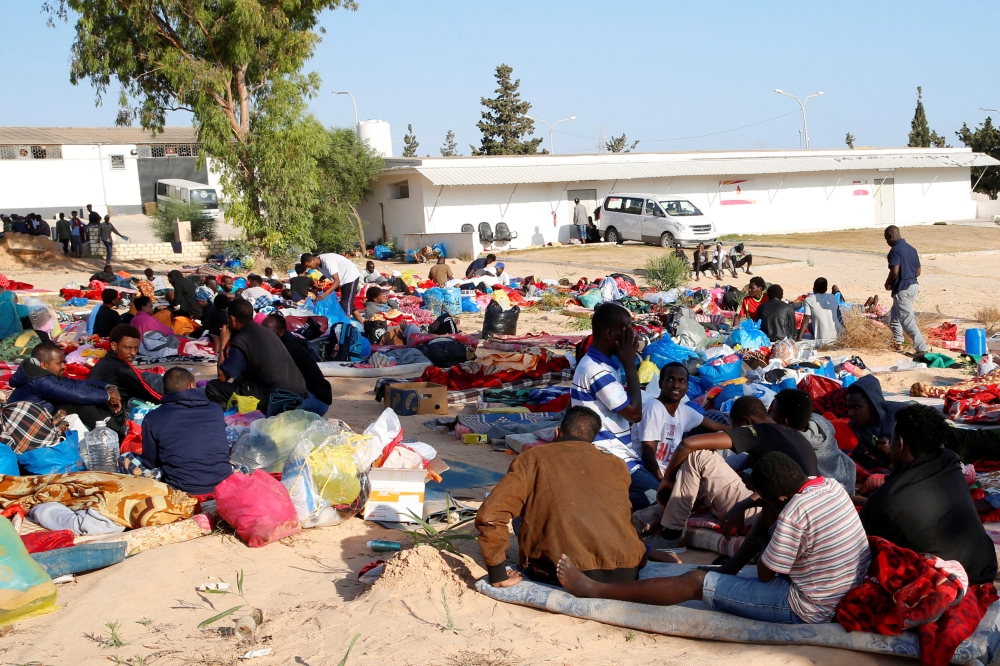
(385, 148), (1000, 186)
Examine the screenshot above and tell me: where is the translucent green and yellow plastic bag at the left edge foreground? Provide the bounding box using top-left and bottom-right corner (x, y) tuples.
(0, 518), (56, 626)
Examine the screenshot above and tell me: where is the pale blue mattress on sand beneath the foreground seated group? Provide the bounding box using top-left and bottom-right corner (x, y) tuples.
(476, 562), (1000, 664)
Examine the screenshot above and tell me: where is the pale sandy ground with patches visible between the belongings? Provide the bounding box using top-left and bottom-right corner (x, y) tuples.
(0, 231), (988, 666)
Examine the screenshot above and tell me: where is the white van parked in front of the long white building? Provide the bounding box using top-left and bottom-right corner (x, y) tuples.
(598, 192), (718, 247)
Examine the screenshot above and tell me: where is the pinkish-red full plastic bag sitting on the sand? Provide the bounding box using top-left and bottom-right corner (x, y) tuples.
(215, 469), (302, 548)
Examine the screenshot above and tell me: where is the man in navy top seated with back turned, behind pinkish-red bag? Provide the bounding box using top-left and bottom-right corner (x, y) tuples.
(139, 366), (231, 495)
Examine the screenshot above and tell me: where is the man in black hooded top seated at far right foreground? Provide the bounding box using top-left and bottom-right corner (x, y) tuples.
(861, 405), (997, 585)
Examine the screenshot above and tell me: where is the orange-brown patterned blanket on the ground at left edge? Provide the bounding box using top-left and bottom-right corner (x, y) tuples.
(0, 472), (197, 528)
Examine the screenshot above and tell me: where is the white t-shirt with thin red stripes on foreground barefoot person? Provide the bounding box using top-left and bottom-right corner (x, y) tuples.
(761, 477), (871, 624)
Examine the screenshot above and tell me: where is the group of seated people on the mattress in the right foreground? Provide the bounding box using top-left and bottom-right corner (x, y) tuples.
(476, 303), (1000, 624)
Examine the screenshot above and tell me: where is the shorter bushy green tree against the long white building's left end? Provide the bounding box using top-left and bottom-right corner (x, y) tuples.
(312, 127), (385, 252)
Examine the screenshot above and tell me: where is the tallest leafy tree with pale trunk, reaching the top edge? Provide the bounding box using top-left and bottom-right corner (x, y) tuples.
(44, 0), (357, 253)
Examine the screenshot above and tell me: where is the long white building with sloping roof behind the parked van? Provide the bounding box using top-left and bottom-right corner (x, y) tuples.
(359, 148), (1000, 254)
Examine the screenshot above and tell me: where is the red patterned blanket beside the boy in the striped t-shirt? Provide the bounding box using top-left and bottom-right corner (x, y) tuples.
(837, 537), (1000, 666)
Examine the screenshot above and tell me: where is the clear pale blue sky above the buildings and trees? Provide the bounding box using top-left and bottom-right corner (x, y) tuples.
(0, 0), (1000, 155)
